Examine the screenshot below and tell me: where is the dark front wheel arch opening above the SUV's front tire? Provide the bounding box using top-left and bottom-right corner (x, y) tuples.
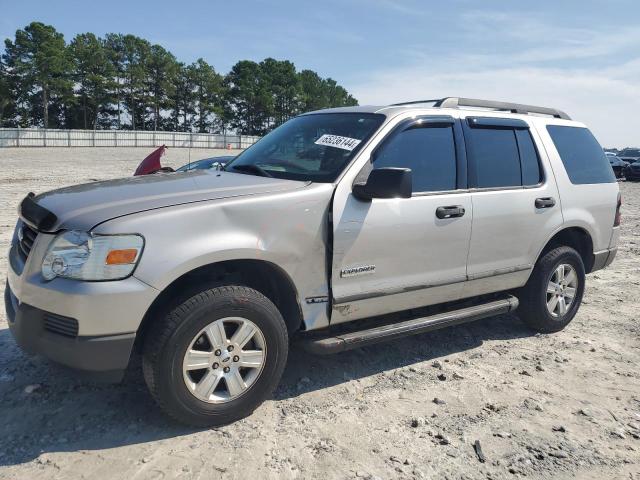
(136, 259), (304, 350)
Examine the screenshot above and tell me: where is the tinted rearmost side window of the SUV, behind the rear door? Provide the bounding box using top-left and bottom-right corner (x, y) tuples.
(547, 125), (616, 185)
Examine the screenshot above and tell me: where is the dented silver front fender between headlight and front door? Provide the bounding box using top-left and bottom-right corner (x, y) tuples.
(94, 184), (333, 329)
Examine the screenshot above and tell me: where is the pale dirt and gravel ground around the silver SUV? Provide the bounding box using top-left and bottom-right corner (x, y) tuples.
(0, 148), (640, 480)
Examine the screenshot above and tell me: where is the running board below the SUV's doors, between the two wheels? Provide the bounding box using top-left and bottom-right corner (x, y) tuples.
(301, 295), (518, 355)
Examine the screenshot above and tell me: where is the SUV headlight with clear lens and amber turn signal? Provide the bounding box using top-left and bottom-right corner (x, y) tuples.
(42, 231), (144, 280)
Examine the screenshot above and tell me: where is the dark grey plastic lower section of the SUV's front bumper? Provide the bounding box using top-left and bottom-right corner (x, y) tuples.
(4, 283), (135, 381)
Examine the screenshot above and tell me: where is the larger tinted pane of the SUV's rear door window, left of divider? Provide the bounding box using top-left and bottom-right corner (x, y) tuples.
(465, 128), (520, 188)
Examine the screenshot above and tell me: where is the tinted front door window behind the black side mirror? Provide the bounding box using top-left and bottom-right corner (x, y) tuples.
(373, 126), (456, 193)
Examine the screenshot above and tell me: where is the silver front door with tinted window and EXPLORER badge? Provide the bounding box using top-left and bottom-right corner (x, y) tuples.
(331, 116), (472, 323)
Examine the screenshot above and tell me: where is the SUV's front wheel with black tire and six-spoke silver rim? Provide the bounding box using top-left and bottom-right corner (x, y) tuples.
(142, 286), (289, 427)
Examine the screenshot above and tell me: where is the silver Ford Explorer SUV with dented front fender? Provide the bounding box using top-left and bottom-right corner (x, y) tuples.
(5, 98), (620, 425)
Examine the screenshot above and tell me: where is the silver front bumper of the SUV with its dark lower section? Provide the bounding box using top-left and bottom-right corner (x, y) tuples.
(4, 233), (159, 381)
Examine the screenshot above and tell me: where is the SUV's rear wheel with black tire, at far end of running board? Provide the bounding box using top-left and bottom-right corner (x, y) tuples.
(517, 247), (585, 333)
